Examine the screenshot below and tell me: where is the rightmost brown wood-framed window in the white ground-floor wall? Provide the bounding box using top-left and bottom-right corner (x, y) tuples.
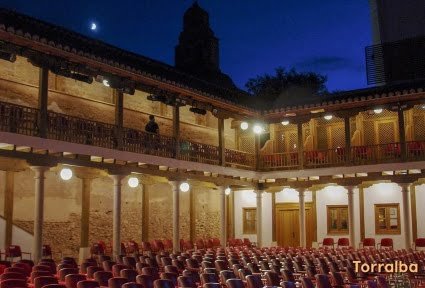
(375, 203), (400, 234)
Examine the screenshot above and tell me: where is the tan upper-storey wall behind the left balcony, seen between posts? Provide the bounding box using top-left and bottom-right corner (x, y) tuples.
(0, 57), (235, 149)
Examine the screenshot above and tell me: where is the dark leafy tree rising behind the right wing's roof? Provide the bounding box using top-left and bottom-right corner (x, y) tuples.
(245, 67), (327, 108)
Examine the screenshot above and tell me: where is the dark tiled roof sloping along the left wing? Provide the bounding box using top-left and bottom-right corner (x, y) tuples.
(0, 8), (253, 111)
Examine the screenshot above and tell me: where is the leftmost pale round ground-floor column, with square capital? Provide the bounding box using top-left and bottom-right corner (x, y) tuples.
(30, 166), (50, 263)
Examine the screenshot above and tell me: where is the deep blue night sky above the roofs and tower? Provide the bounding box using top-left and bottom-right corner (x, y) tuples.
(0, 0), (372, 91)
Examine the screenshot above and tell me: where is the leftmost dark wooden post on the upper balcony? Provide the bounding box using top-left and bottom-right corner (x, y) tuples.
(37, 67), (49, 138)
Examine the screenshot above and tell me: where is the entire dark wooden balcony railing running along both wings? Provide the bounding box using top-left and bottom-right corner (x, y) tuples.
(0, 102), (425, 170)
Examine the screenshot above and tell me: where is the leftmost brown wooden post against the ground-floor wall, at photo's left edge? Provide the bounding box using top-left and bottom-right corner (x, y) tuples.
(4, 171), (15, 247)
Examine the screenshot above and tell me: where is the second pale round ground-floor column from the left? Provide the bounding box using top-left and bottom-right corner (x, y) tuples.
(109, 174), (125, 259)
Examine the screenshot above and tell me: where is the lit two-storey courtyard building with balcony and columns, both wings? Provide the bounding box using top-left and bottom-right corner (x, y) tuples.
(0, 4), (425, 259)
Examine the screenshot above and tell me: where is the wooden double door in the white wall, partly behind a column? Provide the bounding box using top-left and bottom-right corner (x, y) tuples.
(276, 203), (315, 247)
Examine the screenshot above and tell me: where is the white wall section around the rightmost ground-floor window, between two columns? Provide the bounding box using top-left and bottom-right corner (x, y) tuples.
(364, 183), (404, 249)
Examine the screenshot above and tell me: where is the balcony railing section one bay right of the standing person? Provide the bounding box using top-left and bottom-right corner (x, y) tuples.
(178, 140), (219, 165)
